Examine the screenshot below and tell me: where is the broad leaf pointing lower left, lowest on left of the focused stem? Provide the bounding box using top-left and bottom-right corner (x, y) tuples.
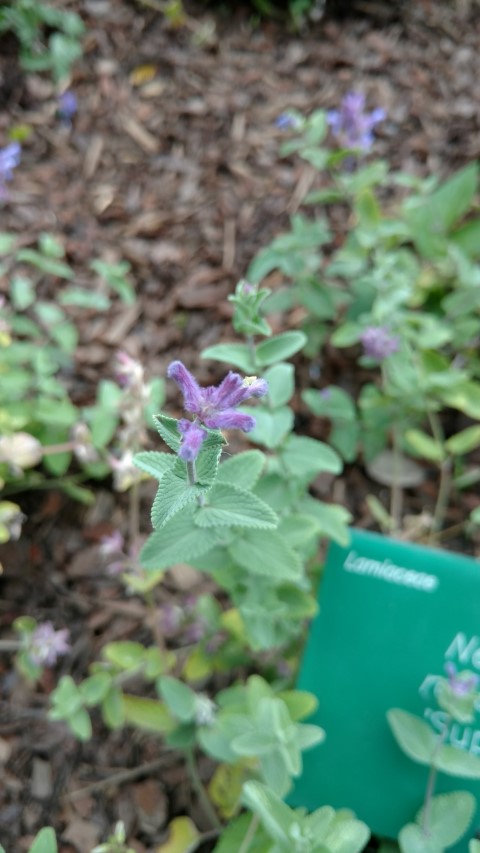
(140, 506), (219, 571)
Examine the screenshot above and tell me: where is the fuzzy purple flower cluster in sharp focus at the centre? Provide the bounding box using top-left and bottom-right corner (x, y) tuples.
(167, 361), (268, 462)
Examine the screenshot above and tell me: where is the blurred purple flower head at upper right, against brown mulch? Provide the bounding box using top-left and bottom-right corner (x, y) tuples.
(327, 92), (386, 151)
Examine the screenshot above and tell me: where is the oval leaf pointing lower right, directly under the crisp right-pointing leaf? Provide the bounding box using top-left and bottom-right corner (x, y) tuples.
(228, 530), (302, 582)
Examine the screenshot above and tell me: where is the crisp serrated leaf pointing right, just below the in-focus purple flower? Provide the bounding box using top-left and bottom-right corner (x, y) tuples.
(195, 483), (278, 529)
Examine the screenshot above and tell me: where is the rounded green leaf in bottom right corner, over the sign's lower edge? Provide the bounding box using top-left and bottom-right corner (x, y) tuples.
(415, 791), (476, 850)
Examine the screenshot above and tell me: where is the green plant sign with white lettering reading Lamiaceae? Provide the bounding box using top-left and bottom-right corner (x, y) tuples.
(290, 530), (480, 853)
